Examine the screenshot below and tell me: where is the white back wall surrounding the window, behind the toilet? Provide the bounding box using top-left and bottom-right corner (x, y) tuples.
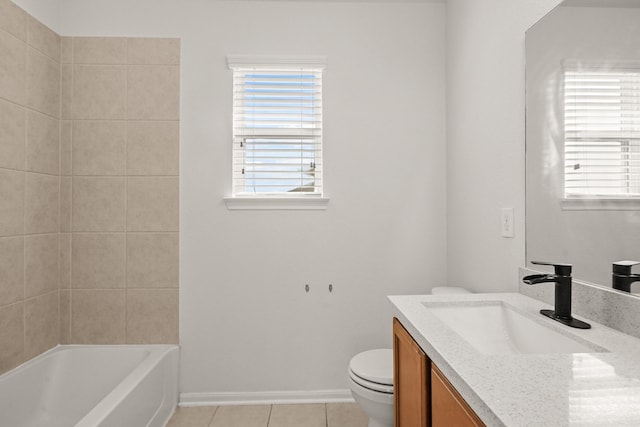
(22, 0), (446, 393)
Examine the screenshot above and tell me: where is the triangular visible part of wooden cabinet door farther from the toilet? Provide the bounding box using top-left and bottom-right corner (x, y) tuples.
(431, 363), (484, 427)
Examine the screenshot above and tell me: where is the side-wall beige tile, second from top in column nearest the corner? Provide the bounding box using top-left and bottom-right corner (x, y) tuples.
(27, 47), (60, 118)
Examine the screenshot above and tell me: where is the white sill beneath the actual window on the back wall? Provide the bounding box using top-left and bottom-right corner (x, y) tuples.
(224, 197), (330, 211)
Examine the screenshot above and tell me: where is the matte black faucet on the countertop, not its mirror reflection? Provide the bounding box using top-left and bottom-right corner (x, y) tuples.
(522, 261), (591, 329)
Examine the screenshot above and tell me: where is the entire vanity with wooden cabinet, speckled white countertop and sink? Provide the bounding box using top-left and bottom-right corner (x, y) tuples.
(389, 293), (640, 427)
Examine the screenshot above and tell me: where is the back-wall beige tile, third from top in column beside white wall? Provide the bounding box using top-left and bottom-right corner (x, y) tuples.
(127, 122), (180, 175)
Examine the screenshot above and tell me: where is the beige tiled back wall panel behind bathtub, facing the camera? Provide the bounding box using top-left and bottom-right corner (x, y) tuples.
(60, 37), (180, 344)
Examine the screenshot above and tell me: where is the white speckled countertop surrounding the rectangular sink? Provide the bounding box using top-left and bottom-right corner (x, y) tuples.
(389, 293), (640, 427)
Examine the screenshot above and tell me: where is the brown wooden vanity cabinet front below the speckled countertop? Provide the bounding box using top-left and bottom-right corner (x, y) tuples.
(393, 318), (484, 427)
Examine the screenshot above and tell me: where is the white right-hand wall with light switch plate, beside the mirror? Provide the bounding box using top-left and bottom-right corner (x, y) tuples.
(446, 0), (559, 292)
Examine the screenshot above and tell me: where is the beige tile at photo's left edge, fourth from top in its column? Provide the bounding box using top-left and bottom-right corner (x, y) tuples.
(0, 169), (25, 236)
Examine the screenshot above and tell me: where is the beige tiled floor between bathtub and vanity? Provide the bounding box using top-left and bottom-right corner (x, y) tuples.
(167, 403), (367, 427)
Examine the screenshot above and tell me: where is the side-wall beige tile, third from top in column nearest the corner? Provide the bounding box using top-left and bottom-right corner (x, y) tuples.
(26, 110), (60, 175)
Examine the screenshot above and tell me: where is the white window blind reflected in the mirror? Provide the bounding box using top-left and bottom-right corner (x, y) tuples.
(564, 70), (640, 197)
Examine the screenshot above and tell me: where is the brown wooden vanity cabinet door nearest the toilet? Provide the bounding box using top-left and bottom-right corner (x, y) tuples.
(393, 318), (429, 427)
